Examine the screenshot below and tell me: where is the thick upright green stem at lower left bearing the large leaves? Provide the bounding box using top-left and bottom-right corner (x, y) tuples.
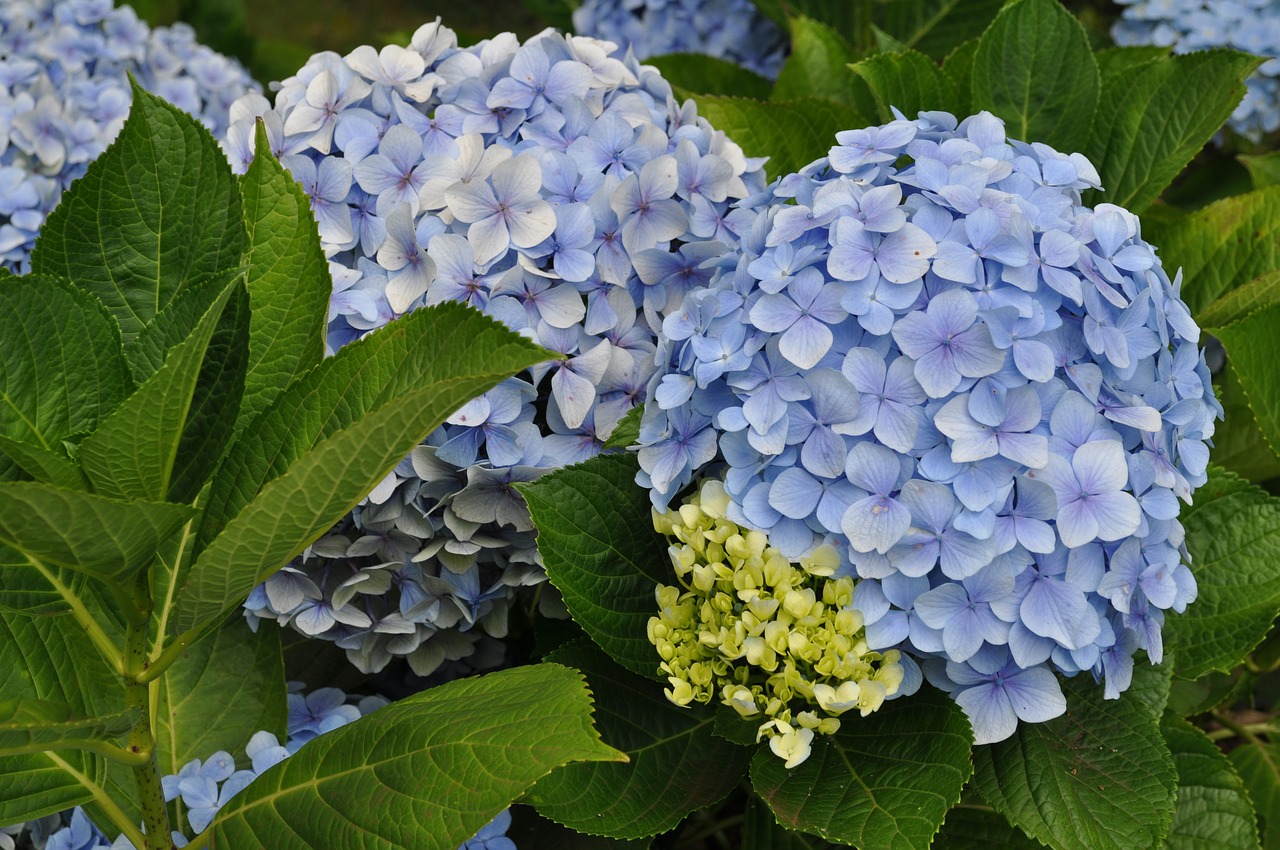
(124, 572), (173, 850)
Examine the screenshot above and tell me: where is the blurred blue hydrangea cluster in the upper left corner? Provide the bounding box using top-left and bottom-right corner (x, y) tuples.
(0, 0), (257, 271)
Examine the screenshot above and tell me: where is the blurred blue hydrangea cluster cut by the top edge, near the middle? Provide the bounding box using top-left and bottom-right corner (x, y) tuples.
(573, 0), (787, 79)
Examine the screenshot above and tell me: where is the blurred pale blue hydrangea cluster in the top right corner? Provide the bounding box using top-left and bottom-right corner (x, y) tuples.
(1111, 0), (1280, 141)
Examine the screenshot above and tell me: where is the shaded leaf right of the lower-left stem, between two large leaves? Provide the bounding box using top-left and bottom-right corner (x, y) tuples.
(155, 617), (288, 824)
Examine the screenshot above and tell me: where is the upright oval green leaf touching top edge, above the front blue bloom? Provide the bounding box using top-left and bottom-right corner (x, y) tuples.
(973, 0), (1100, 152)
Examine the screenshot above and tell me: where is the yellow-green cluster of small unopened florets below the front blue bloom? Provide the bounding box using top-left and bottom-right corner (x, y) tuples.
(649, 480), (902, 768)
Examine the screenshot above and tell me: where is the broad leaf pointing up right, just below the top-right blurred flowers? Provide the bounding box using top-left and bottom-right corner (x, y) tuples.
(1084, 50), (1261, 212)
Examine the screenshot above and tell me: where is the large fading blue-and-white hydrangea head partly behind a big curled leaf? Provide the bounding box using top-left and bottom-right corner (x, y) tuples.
(225, 20), (764, 675)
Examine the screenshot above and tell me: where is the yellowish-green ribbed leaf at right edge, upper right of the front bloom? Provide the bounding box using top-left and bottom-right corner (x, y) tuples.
(1146, 183), (1280, 316)
